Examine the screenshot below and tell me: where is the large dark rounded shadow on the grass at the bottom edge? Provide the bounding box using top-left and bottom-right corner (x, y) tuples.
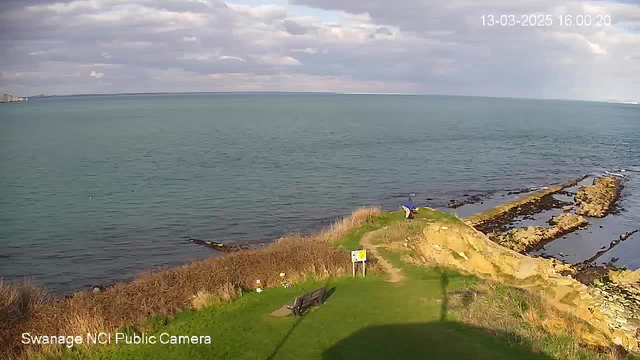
(322, 321), (551, 360)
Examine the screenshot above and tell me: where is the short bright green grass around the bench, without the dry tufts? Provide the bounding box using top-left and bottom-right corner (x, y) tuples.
(48, 210), (608, 360)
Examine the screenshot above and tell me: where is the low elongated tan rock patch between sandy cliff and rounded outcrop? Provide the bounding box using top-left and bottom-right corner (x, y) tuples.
(489, 214), (589, 254)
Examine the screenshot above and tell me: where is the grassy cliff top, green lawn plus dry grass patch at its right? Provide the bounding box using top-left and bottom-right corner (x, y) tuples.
(46, 209), (632, 360)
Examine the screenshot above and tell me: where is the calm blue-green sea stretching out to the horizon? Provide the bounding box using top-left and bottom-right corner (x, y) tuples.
(0, 94), (640, 292)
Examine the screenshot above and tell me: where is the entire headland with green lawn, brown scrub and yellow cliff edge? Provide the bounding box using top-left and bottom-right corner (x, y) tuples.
(0, 189), (633, 359)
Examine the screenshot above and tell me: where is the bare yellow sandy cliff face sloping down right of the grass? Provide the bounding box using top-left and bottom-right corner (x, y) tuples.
(407, 224), (640, 351)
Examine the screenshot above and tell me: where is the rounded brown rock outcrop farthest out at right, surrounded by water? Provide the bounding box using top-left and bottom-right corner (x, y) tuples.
(576, 176), (622, 217)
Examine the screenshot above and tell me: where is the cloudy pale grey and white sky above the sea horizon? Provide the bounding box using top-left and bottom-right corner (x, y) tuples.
(0, 0), (640, 100)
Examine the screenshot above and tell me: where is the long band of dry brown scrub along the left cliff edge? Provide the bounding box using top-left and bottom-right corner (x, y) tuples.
(0, 208), (380, 358)
